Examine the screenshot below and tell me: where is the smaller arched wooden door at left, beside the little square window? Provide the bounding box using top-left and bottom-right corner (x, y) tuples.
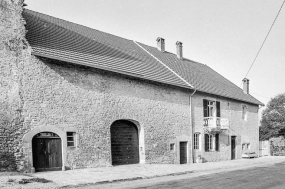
(32, 132), (62, 171)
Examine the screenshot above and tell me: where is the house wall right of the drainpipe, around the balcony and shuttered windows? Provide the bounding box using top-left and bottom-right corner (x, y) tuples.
(192, 93), (259, 162)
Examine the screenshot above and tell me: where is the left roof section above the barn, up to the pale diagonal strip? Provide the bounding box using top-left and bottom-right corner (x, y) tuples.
(23, 9), (191, 88)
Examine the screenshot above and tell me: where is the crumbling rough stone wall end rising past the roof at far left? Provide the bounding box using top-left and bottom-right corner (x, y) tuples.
(0, 0), (31, 171)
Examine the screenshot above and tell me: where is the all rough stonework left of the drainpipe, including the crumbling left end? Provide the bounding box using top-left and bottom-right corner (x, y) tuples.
(0, 0), (192, 171)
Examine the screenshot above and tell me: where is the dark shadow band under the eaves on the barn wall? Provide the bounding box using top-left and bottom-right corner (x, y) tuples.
(37, 57), (189, 106)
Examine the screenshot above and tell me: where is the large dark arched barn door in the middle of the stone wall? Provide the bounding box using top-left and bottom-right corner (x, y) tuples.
(111, 120), (139, 165)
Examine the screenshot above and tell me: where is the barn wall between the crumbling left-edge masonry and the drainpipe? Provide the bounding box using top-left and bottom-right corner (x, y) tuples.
(22, 56), (192, 169)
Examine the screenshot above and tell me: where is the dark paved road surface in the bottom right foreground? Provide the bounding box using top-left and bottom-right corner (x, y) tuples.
(75, 162), (285, 189)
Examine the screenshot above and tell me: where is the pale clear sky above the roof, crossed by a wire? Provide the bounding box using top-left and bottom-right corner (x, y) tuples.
(25, 0), (285, 110)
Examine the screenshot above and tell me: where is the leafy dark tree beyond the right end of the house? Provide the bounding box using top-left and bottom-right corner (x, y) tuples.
(259, 93), (285, 140)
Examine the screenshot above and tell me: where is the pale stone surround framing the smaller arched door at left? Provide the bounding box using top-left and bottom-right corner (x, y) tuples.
(23, 126), (67, 172)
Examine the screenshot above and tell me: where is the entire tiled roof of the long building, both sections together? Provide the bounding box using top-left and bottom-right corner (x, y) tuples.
(23, 9), (262, 104)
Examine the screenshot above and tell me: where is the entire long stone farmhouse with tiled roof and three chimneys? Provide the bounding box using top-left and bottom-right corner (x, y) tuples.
(0, 0), (262, 172)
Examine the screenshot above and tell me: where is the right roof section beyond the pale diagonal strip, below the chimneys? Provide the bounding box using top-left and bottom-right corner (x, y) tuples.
(140, 44), (262, 104)
